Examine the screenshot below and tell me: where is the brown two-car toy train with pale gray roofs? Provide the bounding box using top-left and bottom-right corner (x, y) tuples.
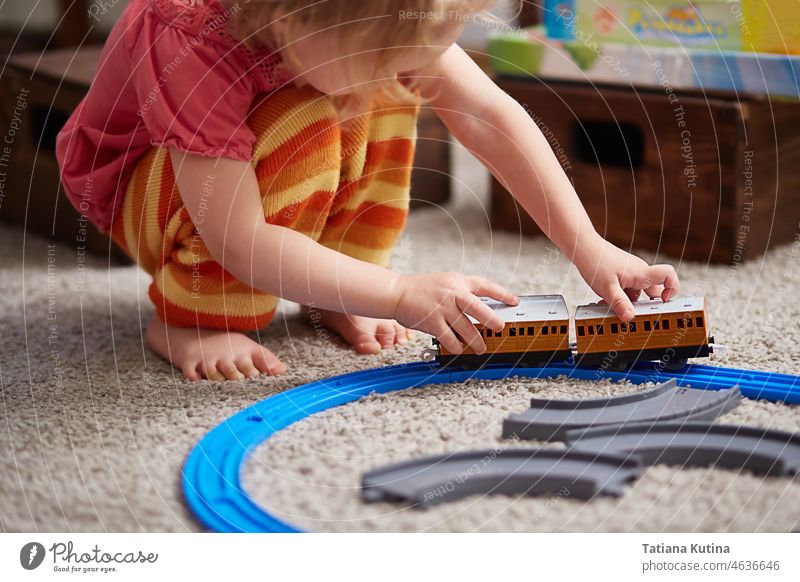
(422, 295), (721, 371)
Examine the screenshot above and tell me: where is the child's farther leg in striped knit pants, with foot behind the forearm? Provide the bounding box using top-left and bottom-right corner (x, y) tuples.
(309, 92), (419, 353)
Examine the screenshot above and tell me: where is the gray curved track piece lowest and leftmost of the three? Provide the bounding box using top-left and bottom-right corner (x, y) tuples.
(361, 449), (641, 507)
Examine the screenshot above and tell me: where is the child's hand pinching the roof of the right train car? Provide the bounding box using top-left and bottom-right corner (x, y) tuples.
(574, 236), (680, 321)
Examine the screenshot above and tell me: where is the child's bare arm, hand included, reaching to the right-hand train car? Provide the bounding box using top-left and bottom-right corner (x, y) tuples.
(409, 45), (679, 320)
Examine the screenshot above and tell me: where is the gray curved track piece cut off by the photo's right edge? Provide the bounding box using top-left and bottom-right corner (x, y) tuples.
(566, 422), (800, 476)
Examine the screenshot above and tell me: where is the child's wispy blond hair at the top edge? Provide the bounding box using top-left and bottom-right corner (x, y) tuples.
(228, 0), (495, 122)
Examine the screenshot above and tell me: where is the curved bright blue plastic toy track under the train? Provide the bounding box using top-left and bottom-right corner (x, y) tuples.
(183, 362), (800, 532)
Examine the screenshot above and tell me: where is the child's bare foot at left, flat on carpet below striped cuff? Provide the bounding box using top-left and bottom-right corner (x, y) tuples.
(147, 319), (286, 380)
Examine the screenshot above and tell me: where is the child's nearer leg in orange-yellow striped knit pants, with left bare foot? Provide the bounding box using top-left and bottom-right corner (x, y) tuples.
(112, 89), (341, 379)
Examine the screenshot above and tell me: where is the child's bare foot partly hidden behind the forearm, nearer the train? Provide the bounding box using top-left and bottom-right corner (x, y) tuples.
(304, 307), (414, 354)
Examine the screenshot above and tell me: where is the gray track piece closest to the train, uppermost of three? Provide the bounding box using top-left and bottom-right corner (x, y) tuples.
(503, 379), (742, 441)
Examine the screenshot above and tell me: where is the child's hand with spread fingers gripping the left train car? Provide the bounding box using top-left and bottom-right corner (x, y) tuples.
(394, 273), (519, 354)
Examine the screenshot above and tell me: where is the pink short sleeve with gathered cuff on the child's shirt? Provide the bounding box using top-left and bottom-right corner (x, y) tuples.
(129, 16), (256, 160)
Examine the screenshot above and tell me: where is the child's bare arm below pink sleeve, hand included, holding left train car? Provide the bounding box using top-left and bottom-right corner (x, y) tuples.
(169, 147), (518, 352)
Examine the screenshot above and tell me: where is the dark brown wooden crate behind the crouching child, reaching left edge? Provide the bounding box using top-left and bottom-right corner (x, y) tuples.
(0, 45), (450, 260)
